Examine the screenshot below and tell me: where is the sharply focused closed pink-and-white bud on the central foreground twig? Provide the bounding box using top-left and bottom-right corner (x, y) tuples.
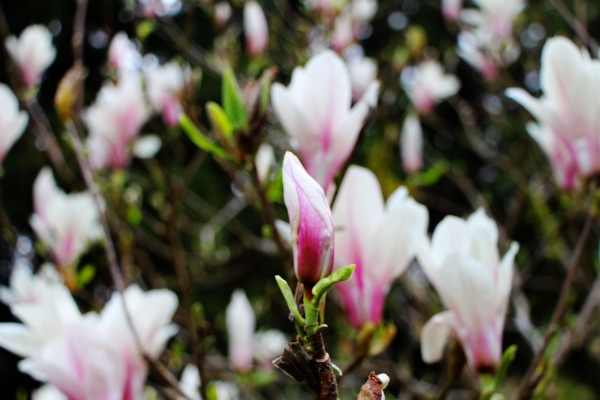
(283, 152), (334, 293)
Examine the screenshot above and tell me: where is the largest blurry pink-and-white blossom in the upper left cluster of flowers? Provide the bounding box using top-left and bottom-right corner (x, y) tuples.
(84, 73), (150, 169)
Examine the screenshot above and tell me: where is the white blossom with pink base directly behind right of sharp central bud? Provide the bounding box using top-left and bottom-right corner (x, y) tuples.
(333, 165), (429, 329)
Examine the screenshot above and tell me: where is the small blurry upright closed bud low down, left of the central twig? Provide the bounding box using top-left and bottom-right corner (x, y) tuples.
(225, 289), (256, 372)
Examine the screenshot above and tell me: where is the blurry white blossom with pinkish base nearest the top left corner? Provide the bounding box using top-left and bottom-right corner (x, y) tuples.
(5, 25), (56, 87)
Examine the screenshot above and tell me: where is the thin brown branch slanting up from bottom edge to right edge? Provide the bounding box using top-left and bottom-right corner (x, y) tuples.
(513, 210), (596, 400)
